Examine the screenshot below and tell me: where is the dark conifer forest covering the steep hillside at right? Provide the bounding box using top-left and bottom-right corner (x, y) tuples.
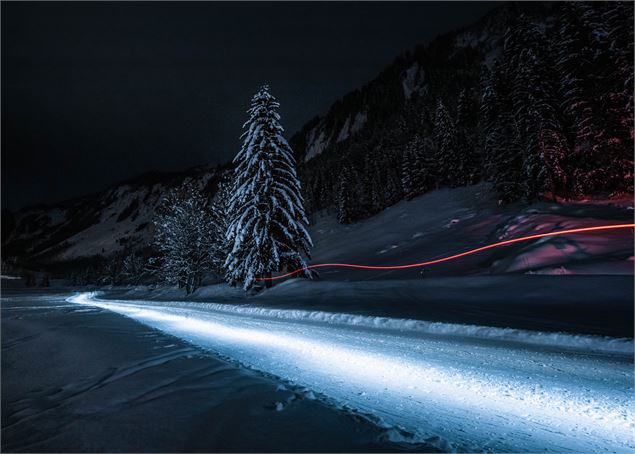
(300, 2), (633, 223)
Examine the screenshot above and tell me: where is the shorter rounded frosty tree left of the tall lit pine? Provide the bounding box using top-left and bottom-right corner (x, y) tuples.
(154, 182), (217, 294)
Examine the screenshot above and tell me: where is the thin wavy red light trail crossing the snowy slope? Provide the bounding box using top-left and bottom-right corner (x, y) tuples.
(256, 224), (635, 281)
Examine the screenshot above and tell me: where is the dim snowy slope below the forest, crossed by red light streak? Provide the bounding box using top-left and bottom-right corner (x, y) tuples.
(310, 184), (633, 280)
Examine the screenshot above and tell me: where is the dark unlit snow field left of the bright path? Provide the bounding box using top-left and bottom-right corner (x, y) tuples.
(1, 290), (402, 452)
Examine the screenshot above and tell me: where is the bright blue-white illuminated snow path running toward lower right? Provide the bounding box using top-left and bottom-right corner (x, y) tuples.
(69, 293), (635, 452)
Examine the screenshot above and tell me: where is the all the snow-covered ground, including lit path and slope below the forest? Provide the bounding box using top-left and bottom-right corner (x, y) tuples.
(2, 185), (635, 452)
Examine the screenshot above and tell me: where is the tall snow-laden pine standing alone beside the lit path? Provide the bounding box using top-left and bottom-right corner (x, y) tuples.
(225, 85), (313, 290)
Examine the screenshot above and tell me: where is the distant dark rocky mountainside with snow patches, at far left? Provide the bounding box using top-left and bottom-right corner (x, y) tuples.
(2, 167), (230, 264)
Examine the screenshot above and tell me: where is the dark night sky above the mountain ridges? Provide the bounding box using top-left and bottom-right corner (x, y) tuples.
(1, 2), (500, 209)
